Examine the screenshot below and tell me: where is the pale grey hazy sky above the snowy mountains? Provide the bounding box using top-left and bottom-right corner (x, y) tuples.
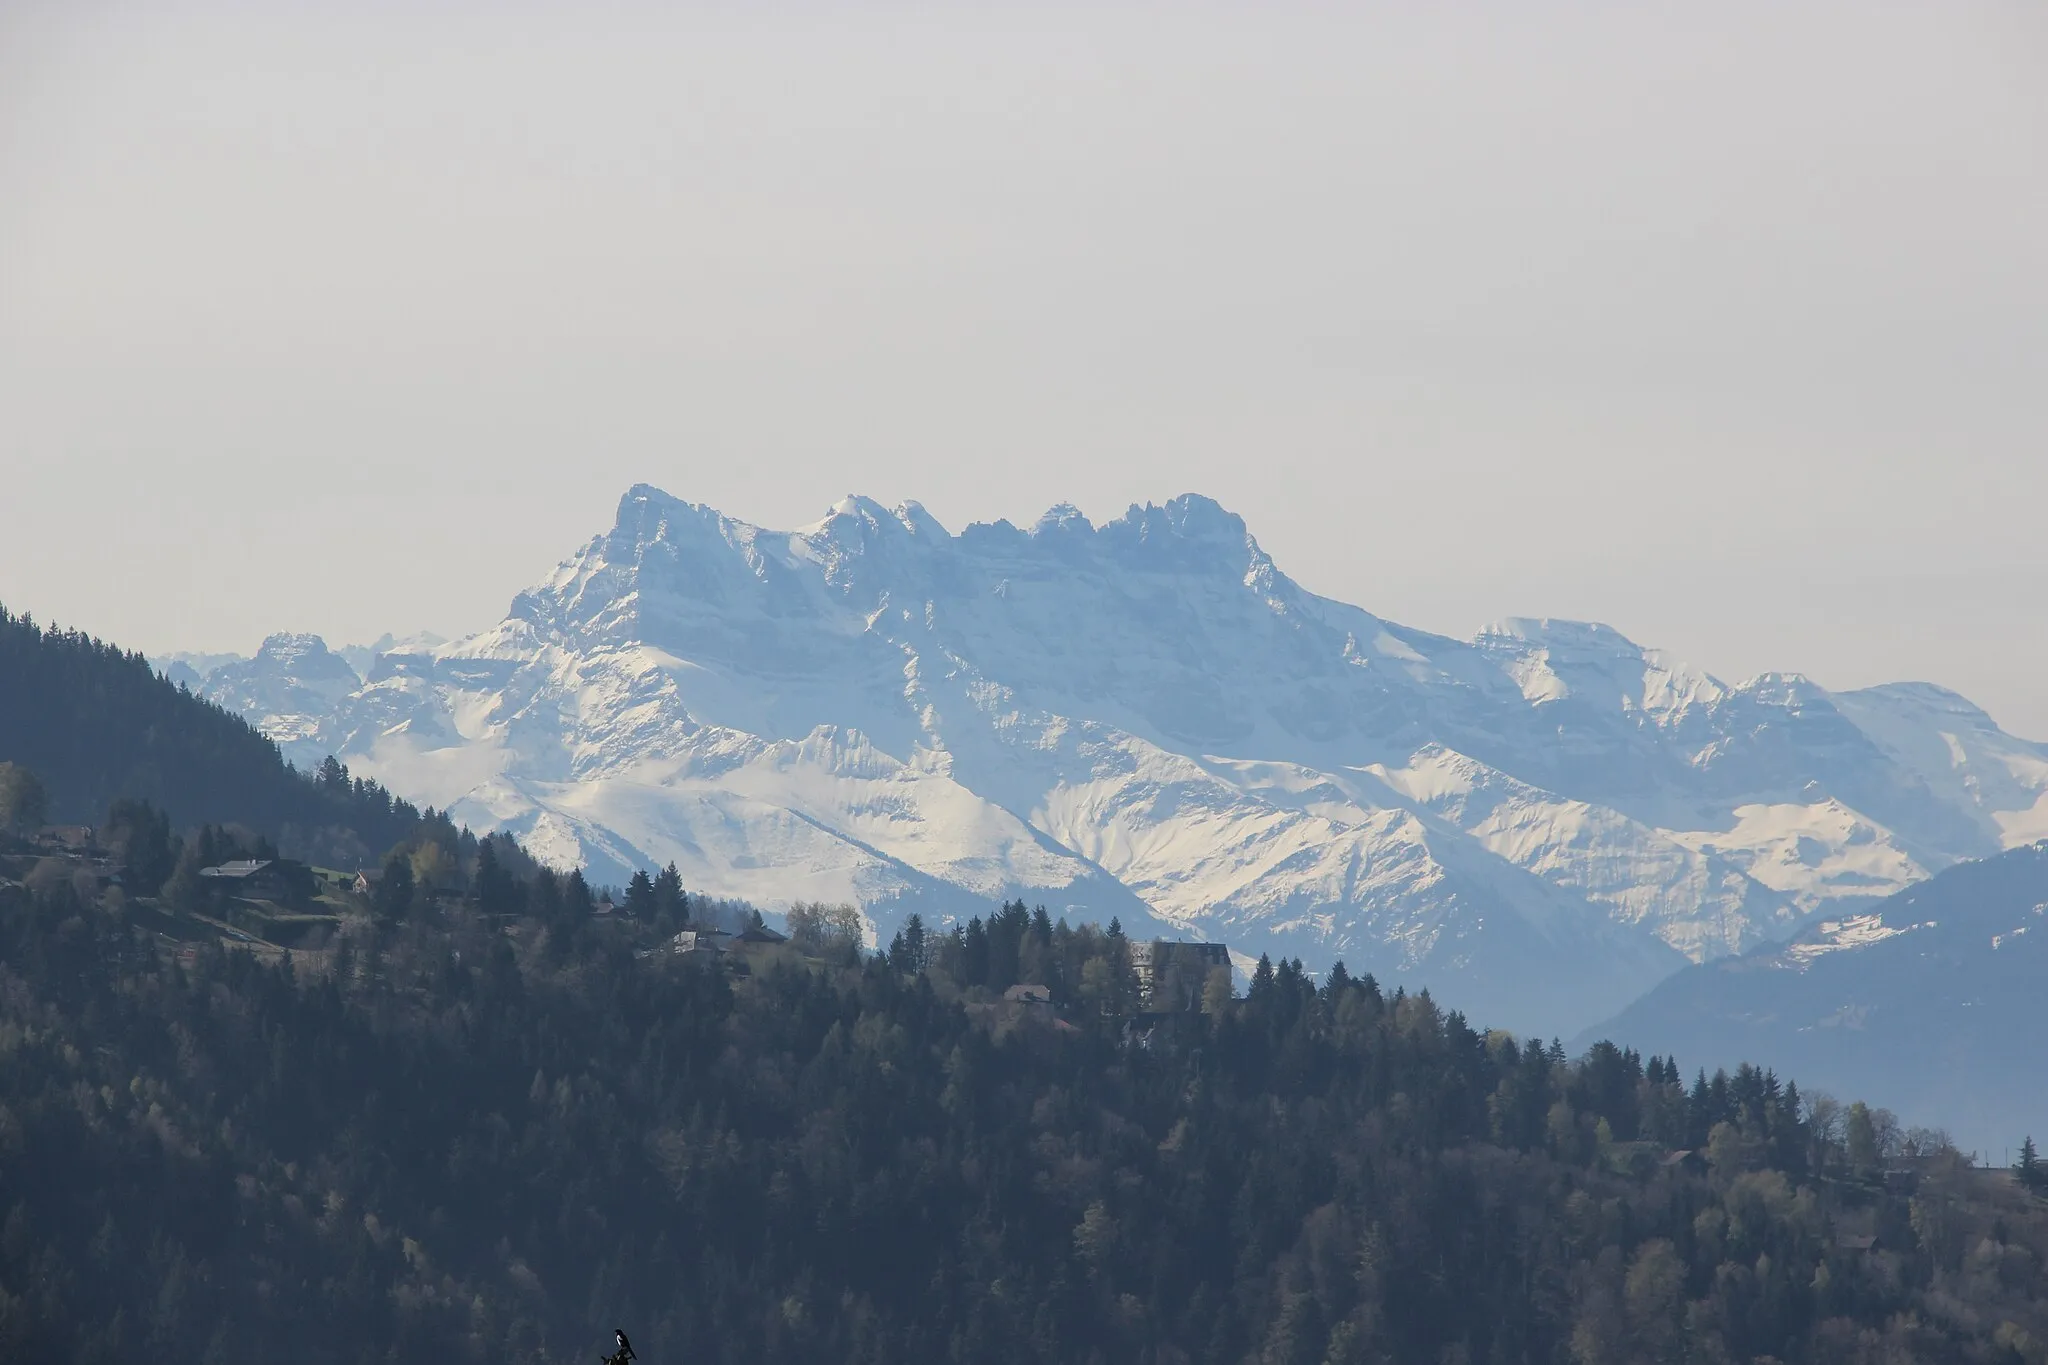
(12, 0), (2048, 739)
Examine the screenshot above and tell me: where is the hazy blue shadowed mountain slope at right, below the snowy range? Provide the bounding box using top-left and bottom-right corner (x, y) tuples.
(1581, 843), (2048, 1162)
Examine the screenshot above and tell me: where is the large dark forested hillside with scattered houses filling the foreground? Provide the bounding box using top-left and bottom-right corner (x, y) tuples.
(0, 841), (2048, 1365)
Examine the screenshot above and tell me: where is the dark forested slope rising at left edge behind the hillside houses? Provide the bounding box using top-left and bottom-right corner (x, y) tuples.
(0, 608), (420, 866)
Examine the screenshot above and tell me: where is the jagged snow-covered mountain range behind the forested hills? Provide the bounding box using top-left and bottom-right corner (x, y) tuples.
(174, 485), (2048, 1033)
